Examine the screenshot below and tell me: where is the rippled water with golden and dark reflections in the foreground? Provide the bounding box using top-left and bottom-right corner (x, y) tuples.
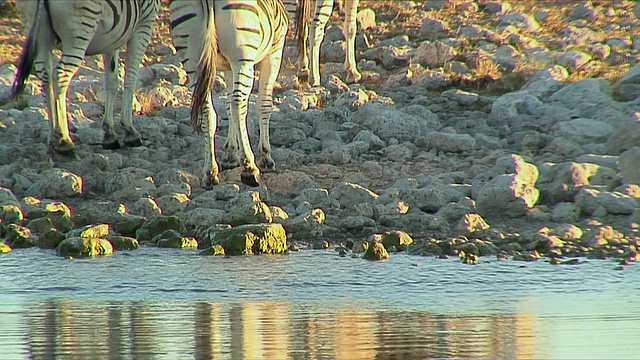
(0, 248), (640, 360)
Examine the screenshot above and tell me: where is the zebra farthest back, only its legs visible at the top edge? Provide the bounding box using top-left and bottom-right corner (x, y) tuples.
(284, 0), (362, 86)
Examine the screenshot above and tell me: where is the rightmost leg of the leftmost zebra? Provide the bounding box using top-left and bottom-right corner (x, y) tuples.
(122, 26), (153, 146)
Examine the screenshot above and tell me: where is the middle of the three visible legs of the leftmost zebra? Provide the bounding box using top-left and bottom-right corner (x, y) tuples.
(102, 50), (120, 150)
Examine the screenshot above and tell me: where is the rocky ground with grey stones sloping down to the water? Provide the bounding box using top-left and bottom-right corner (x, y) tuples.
(0, 0), (640, 269)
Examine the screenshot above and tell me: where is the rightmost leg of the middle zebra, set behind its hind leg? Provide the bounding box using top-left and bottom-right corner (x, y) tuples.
(258, 48), (284, 171)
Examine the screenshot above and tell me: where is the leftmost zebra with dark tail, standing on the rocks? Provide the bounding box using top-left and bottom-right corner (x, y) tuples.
(12, 0), (161, 156)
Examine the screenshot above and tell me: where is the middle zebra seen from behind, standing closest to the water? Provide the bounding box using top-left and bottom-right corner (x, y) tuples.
(169, 0), (289, 188)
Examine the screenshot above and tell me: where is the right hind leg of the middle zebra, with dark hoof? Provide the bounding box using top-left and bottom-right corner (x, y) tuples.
(227, 58), (260, 186)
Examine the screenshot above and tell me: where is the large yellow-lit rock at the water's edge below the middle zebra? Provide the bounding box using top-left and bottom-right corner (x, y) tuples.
(216, 223), (287, 255)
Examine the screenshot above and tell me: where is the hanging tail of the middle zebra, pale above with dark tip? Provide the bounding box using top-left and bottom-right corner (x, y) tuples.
(191, 9), (218, 131)
